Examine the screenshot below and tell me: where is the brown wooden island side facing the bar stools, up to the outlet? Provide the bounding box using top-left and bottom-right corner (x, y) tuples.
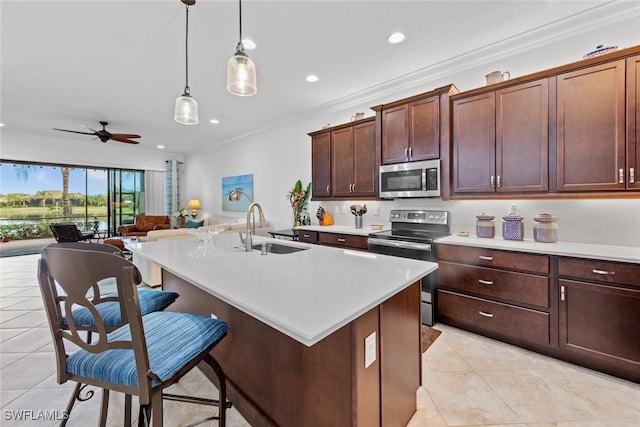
(162, 270), (380, 427)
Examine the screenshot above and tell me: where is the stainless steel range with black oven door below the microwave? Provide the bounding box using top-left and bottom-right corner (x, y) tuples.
(369, 209), (450, 326)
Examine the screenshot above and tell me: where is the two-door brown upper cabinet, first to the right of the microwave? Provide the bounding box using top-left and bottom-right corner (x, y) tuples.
(453, 79), (549, 193)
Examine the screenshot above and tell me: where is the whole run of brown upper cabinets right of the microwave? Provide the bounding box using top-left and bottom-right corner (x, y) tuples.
(451, 47), (640, 198)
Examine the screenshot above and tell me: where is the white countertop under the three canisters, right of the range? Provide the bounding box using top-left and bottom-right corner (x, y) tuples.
(436, 235), (640, 263)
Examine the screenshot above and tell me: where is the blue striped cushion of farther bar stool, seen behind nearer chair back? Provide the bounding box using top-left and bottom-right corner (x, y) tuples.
(63, 289), (179, 327)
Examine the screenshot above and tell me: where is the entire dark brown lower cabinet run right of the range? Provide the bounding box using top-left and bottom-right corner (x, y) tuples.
(436, 244), (640, 383)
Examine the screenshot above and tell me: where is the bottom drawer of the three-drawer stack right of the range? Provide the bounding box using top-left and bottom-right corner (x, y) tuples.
(437, 289), (550, 345)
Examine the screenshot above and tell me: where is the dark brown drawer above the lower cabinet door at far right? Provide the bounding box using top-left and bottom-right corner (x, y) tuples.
(558, 258), (640, 286)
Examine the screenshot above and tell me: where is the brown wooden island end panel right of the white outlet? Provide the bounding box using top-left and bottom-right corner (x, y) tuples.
(380, 282), (422, 427)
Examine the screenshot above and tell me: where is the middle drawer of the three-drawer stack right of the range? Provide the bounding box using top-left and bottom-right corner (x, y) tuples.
(438, 262), (549, 309)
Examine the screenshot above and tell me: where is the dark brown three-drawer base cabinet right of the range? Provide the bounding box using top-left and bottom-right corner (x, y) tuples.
(437, 245), (553, 346)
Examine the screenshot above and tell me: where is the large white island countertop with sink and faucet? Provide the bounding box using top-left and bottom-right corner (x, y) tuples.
(128, 233), (438, 346)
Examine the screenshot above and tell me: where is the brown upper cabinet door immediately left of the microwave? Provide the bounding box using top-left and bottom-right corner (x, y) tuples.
(352, 122), (378, 197)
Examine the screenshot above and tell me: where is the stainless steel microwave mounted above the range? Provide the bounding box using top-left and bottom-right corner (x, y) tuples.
(380, 159), (440, 199)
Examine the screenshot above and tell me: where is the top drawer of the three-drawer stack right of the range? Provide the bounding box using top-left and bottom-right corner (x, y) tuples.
(436, 244), (549, 274)
